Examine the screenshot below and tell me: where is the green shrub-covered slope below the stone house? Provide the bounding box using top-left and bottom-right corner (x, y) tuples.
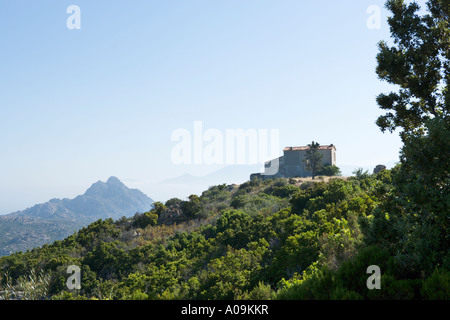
(0, 167), (450, 300)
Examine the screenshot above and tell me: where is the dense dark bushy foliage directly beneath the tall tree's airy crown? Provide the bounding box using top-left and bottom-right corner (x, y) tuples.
(390, 118), (450, 275)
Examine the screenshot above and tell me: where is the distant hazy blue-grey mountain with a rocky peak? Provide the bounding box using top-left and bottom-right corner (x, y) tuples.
(0, 177), (153, 255)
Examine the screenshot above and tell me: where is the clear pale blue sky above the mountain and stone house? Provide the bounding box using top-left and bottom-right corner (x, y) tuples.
(0, 0), (422, 214)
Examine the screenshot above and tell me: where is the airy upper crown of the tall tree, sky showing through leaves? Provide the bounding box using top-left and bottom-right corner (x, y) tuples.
(376, 0), (450, 139)
